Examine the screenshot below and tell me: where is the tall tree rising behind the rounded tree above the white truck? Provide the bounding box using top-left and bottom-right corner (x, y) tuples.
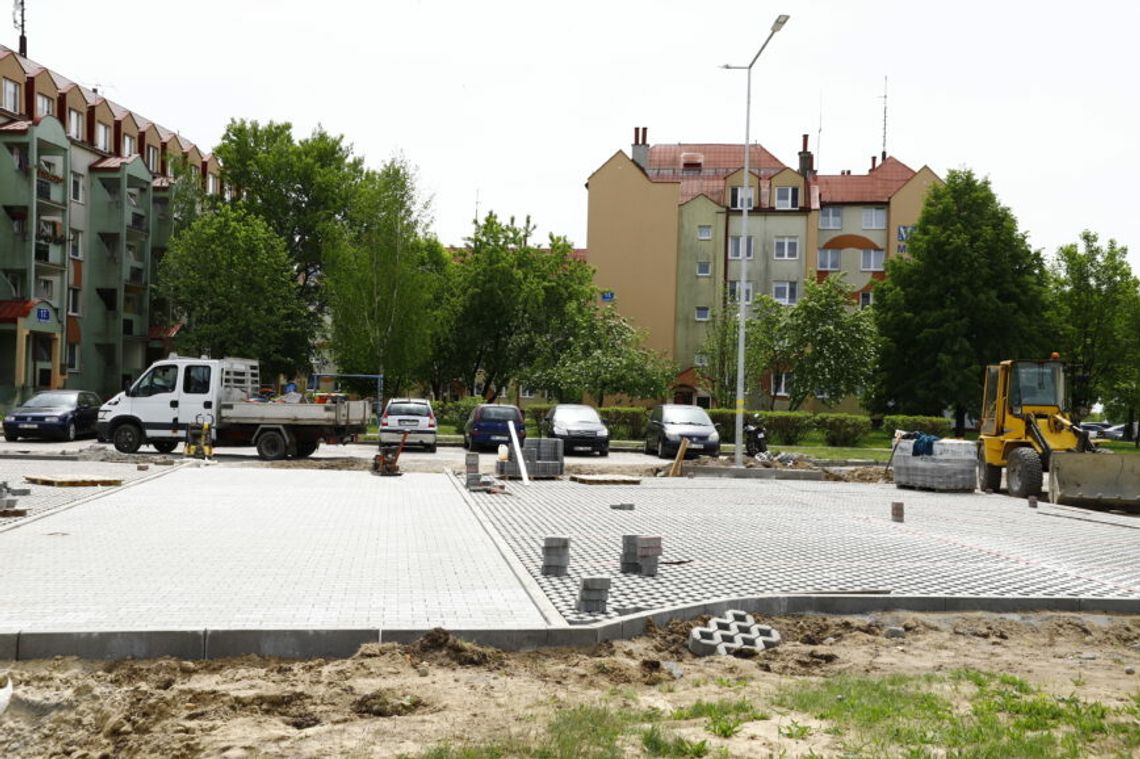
(214, 120), (365, 308)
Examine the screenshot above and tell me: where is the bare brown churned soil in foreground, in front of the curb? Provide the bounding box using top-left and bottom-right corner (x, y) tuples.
(0, 612), (1140, 758)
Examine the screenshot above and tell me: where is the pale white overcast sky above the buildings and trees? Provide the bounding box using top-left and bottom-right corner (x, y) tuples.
(13, 0), (1140, 272)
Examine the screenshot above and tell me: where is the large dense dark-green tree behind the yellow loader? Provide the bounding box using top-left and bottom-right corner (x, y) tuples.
(869, 170), (1049, 433)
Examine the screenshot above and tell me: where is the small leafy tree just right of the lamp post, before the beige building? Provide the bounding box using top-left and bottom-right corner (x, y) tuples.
(785, 276), (878, 410)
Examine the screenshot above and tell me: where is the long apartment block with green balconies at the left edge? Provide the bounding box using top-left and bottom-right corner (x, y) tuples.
(0, 46), (220, 408)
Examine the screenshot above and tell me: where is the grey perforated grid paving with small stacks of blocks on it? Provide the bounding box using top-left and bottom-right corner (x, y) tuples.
(470, 479), (1140, 623)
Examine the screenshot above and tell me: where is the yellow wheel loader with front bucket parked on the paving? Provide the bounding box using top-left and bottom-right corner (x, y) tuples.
(978, 353), (1140, 509)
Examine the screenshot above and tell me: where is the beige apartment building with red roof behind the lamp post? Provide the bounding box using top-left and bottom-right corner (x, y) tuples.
(587, 128), (941, 407)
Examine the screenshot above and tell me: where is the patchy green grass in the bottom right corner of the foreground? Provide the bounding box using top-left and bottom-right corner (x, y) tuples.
(776, 669), (1140, 758)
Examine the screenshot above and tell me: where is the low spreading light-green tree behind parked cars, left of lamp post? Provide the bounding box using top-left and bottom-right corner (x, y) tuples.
(523, 305), (677, 406)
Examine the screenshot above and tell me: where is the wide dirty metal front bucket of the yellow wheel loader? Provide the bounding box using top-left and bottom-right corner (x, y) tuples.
(1049, 451), (1140, 511)
